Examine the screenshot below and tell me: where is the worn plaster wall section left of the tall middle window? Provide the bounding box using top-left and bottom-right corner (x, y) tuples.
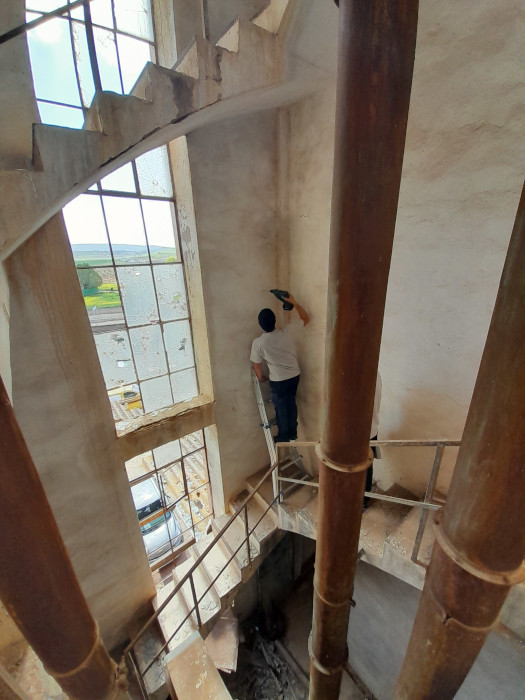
(6, 215), (154, 648)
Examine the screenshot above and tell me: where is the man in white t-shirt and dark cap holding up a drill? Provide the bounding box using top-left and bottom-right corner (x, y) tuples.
(250, 294), (310, 442)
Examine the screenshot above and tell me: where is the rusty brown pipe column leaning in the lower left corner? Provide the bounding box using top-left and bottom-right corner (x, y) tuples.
(0, 379), (122, 700)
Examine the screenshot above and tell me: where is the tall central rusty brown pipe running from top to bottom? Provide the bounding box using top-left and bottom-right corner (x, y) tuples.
(309, 0), (418, 700)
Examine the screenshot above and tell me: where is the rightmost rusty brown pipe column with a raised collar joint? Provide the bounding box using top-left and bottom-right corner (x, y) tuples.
(395, 187), (525, 700)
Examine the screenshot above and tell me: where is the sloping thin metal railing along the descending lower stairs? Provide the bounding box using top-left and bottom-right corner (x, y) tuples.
(123, 464), (277, 700)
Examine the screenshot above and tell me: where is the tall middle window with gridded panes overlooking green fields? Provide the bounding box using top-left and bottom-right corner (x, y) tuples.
(63, 146), (199, 431)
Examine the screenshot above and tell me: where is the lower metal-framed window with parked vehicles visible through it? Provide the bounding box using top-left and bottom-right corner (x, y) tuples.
(126, 430), (213, 568)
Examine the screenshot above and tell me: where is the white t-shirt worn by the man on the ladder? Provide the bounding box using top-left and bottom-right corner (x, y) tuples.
(250, 325), (301, 382)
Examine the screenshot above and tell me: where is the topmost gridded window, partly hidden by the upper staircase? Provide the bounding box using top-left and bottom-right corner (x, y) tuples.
(26, 0), (156, 129)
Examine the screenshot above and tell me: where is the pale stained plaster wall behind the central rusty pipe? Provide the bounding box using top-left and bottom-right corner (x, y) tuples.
(288, 0), (525, 493)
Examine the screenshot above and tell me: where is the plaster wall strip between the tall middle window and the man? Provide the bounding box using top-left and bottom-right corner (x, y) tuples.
(187, 111), (278, 499)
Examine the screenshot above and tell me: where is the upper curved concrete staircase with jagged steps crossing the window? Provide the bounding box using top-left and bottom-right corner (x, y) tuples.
(0, 0), (313, 258)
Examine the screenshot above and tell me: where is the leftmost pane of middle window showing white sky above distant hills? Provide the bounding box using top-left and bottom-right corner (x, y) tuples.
(62, 194), (112, 266)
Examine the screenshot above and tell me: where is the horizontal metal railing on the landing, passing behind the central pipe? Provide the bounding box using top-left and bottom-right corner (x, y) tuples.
(272, 440), (461, 567)
